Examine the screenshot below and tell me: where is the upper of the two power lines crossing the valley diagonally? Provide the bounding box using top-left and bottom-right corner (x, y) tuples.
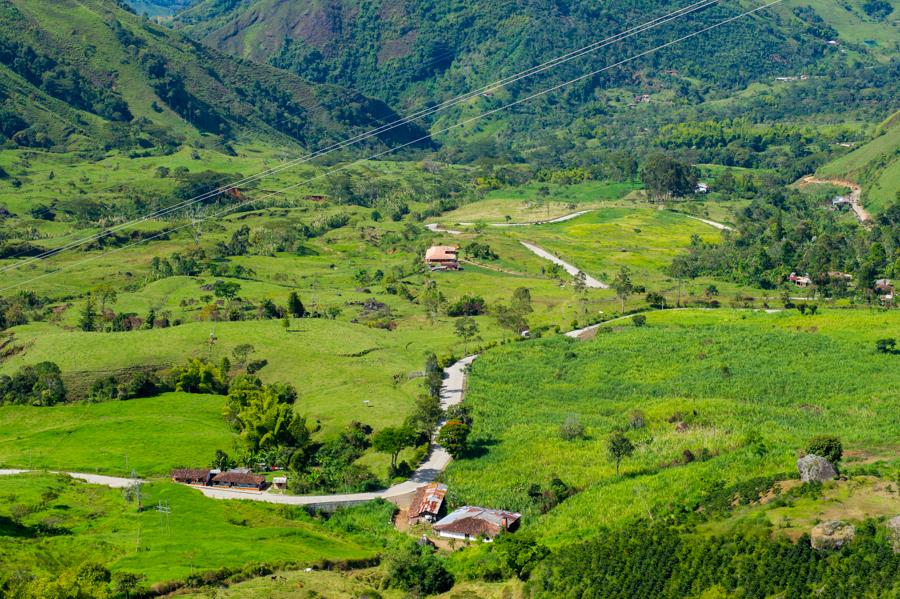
(0, 0), (720, 272)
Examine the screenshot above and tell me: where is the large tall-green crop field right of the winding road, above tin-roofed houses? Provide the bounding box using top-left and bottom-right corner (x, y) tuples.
(446, 310), (900, 543)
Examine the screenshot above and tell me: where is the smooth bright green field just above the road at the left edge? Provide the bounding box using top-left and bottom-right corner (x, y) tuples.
(0, 393), (235, 477)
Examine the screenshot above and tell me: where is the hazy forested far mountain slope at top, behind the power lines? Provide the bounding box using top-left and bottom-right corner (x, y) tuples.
(176, 0), (897, 110)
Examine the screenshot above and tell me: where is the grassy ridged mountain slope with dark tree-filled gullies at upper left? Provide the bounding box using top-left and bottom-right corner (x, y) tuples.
(0, 0), (426, 149)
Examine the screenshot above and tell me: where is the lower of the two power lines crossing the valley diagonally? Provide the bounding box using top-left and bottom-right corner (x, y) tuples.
(0, 0), (784, 292)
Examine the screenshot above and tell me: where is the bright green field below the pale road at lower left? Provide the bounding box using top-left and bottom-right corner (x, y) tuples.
(0, 475), (393, 585)
